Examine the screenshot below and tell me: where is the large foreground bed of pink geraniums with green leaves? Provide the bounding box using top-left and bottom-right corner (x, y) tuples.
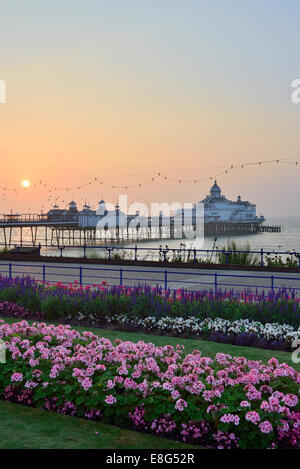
(0, 320), (300, 448)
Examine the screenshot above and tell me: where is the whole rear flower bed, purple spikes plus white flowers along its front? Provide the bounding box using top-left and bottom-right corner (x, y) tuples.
(0, 277), (300, 351)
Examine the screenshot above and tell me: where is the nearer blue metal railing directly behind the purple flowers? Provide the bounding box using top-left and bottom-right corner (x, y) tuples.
(0, 262), (300, 291)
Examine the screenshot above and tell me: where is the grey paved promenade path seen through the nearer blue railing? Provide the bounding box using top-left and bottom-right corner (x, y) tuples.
(0, 261), (300, 296)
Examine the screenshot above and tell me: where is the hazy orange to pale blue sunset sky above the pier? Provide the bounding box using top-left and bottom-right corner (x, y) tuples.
(0, 0), (300, 218)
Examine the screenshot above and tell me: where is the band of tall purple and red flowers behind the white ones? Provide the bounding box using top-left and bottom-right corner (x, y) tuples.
(0, 277), (300, 329)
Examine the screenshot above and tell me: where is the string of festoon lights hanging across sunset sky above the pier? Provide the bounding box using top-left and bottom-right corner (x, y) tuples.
(0, 157), (300, 200)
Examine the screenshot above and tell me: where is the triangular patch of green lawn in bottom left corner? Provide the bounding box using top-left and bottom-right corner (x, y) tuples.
(0, 401), (195, 450)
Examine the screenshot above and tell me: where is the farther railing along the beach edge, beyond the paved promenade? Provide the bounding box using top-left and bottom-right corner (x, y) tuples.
(0, 243), (300, 268)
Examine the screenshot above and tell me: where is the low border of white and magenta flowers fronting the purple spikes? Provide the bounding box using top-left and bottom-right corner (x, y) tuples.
(0, 301), (300, 351)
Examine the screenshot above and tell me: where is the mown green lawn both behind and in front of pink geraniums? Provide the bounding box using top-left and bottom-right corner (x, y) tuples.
(0, 317), (300, 449)
